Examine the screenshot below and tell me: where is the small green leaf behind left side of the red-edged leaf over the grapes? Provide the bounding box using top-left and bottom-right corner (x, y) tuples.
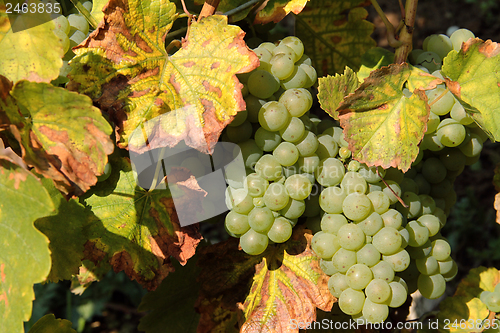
(318, 67), (359, 120)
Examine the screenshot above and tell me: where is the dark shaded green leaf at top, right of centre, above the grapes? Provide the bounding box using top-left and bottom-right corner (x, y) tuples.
(296, 0), (376, 77)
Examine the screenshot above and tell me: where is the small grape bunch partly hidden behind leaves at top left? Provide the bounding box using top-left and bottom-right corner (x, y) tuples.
(53, 1), (92, 84)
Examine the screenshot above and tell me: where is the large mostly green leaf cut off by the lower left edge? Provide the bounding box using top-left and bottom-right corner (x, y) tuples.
(0, 156), (54, 333)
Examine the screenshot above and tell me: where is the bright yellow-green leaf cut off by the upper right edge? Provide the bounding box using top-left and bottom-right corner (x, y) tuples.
(441, 38), (500, 141)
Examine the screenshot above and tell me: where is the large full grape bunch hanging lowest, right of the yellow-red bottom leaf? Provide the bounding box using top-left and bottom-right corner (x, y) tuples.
(309, 121), (457, 322)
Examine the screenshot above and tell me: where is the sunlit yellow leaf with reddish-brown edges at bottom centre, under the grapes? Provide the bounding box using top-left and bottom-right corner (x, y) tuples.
(241, 230), (334, 333)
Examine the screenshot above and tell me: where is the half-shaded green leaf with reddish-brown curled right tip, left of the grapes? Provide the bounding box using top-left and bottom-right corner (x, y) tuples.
(82, 155), (202, 290)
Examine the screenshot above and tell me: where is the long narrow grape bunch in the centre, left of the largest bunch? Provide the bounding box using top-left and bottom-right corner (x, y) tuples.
(222, 37), (320, 255)
